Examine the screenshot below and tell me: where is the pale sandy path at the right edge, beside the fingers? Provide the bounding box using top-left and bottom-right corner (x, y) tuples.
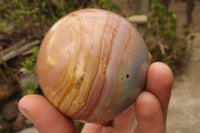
(167, 32), (200, 133)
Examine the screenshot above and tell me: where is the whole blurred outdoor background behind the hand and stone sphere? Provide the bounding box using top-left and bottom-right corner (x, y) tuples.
(0, 0), (200, 133)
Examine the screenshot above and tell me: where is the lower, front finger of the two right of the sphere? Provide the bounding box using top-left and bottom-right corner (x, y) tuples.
(134, 92), (165, 133)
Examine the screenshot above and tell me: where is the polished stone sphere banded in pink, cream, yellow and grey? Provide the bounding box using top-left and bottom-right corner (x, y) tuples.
(37, 9), (149, 123)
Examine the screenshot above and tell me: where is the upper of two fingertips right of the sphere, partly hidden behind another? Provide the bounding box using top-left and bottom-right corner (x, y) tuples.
(146, 62), (173, 120)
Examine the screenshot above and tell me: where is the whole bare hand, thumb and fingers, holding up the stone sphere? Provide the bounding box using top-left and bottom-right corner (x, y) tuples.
(19, 62), (173, 133)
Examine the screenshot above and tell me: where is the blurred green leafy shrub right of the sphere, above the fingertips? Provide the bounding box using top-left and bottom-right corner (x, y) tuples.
(147, 4), (191, 69)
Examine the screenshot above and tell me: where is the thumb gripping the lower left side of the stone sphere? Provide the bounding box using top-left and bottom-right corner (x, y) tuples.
(18, 95), (76, 133)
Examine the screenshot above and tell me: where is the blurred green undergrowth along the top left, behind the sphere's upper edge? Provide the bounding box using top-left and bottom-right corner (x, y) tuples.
(0, 0), (120, 41)
